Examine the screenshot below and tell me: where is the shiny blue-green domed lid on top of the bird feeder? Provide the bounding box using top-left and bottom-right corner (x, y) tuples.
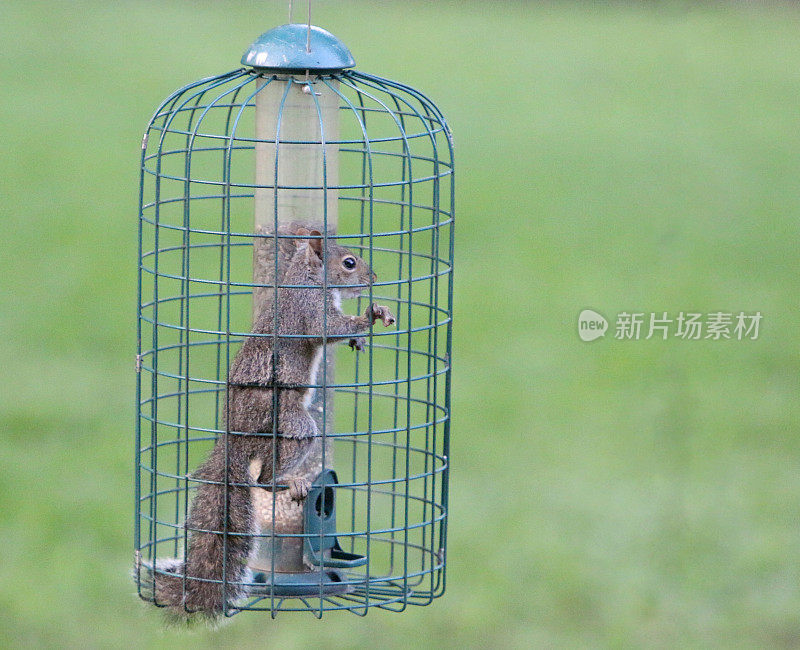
(242, 24), (356, 71)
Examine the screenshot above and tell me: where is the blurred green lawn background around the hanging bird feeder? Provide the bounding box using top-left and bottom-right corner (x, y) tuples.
(0, 0), (800, 648)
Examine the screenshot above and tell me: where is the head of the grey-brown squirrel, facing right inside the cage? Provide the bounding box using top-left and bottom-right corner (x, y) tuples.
(295, 228), (378, 298)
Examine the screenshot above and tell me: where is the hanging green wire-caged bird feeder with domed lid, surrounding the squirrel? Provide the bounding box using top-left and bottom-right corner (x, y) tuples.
(134, 24), (454, 616)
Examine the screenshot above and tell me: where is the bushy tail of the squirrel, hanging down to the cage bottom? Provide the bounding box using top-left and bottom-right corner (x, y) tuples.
(143, 444), (253, 620)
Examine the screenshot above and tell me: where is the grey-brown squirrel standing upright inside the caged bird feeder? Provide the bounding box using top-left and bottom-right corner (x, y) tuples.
(145, 227), (395, 621)
